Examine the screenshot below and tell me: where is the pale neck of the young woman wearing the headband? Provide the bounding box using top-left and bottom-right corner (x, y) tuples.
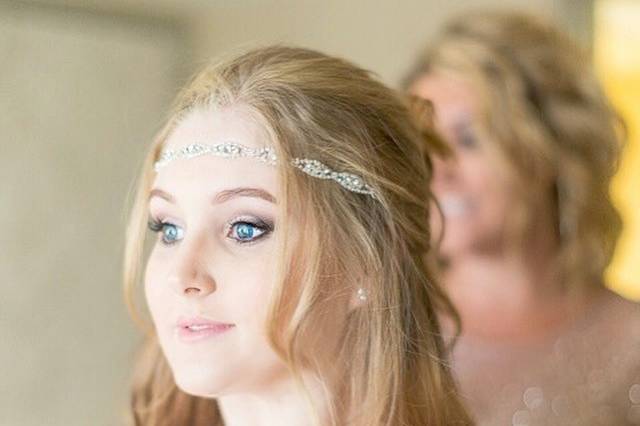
(217, 372), (328, 426)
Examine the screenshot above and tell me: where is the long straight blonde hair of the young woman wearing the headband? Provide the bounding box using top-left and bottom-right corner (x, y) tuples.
(125, 47), (470, 426)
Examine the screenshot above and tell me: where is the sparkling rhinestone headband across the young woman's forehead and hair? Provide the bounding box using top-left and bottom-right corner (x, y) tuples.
(153, 142), (377, 198)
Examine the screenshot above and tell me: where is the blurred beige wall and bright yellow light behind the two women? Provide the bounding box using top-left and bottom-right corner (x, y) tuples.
(0, 0), (640, 426)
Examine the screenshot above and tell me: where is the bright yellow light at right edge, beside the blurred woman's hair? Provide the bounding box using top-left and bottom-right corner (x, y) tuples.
(594, 0), (640, 300)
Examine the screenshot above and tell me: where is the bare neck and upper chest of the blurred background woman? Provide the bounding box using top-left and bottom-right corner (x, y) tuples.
(444, 226), (587, 342)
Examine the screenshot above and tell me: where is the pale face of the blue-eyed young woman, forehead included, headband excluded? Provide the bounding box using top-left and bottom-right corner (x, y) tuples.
(145, 108), (286, 397)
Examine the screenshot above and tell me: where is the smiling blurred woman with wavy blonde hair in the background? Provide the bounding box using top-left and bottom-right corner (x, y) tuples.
(405, 13), (640, 425)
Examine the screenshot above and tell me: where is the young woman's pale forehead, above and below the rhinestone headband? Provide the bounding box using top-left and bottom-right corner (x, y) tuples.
(154, 106), (277, 196)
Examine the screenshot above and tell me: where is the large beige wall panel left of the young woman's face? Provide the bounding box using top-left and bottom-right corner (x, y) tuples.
(0, 3), (180, 426)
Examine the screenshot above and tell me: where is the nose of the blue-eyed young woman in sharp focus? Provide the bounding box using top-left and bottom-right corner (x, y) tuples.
(169, 240), (216, 298)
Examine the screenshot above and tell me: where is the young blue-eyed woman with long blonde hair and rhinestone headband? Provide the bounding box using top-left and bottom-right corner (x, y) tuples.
(125, 47), (470, 426)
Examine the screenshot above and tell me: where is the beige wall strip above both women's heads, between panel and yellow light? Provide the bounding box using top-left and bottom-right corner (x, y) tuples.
(193, 0), (589, 85)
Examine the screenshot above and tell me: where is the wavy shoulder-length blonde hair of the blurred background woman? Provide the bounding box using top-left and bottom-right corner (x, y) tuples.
(404, 12), (624, 289)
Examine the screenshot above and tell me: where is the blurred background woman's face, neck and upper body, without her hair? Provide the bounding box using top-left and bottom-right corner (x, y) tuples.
(412, 74), (640, 425)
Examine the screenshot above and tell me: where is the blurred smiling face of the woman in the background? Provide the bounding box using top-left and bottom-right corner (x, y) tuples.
(412, 74), (513, 257)
